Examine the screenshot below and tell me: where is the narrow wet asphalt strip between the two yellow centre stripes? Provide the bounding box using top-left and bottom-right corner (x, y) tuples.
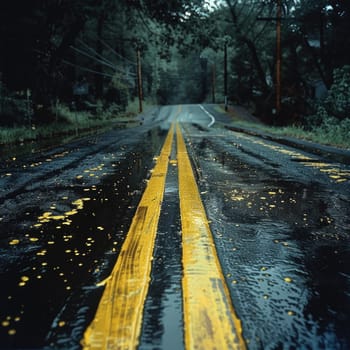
(139, 146), (183, 350)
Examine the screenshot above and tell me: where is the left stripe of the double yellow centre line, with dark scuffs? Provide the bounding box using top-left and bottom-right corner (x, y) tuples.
(82, 126), (174, 350)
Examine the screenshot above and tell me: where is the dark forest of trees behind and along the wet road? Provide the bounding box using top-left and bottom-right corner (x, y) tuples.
(0, 0), (350, 144)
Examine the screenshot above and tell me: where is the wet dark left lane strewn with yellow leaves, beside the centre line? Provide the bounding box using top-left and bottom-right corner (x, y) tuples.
(0, 108), (167, 349)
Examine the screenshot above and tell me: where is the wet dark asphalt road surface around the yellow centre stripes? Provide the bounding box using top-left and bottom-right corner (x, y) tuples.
(0, 105), (350, 349)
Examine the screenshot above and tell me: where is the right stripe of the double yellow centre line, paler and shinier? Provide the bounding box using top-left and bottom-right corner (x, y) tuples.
(176, 125), (246, 350)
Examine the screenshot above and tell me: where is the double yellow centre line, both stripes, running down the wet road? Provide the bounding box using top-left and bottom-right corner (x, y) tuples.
(82, 121), (245, 350)
